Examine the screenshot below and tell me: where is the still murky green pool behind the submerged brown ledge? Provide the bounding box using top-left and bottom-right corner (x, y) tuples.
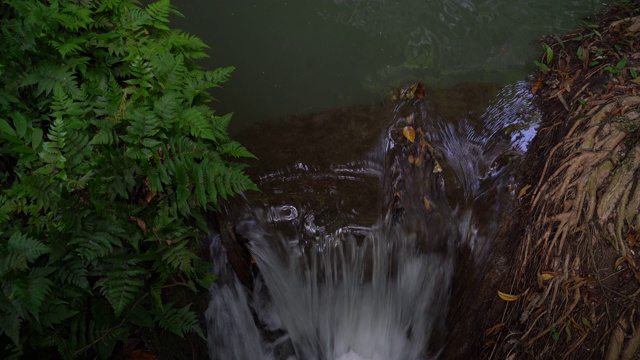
(172, 0), (602, 127)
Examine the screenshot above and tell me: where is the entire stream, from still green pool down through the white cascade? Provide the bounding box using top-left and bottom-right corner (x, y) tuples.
(172, 0), (602, 360)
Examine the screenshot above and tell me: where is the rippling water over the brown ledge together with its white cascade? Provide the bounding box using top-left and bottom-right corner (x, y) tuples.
(206, 82), (538, 360)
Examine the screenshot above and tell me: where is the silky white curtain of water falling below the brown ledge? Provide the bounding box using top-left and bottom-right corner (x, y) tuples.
(238, 212), (454, 360)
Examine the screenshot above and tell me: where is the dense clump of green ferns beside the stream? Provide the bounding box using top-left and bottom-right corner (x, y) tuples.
(0, 0), (255, 359)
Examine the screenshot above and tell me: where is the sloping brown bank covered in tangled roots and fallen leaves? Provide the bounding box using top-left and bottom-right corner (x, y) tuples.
(445, 1), (640, 360)
